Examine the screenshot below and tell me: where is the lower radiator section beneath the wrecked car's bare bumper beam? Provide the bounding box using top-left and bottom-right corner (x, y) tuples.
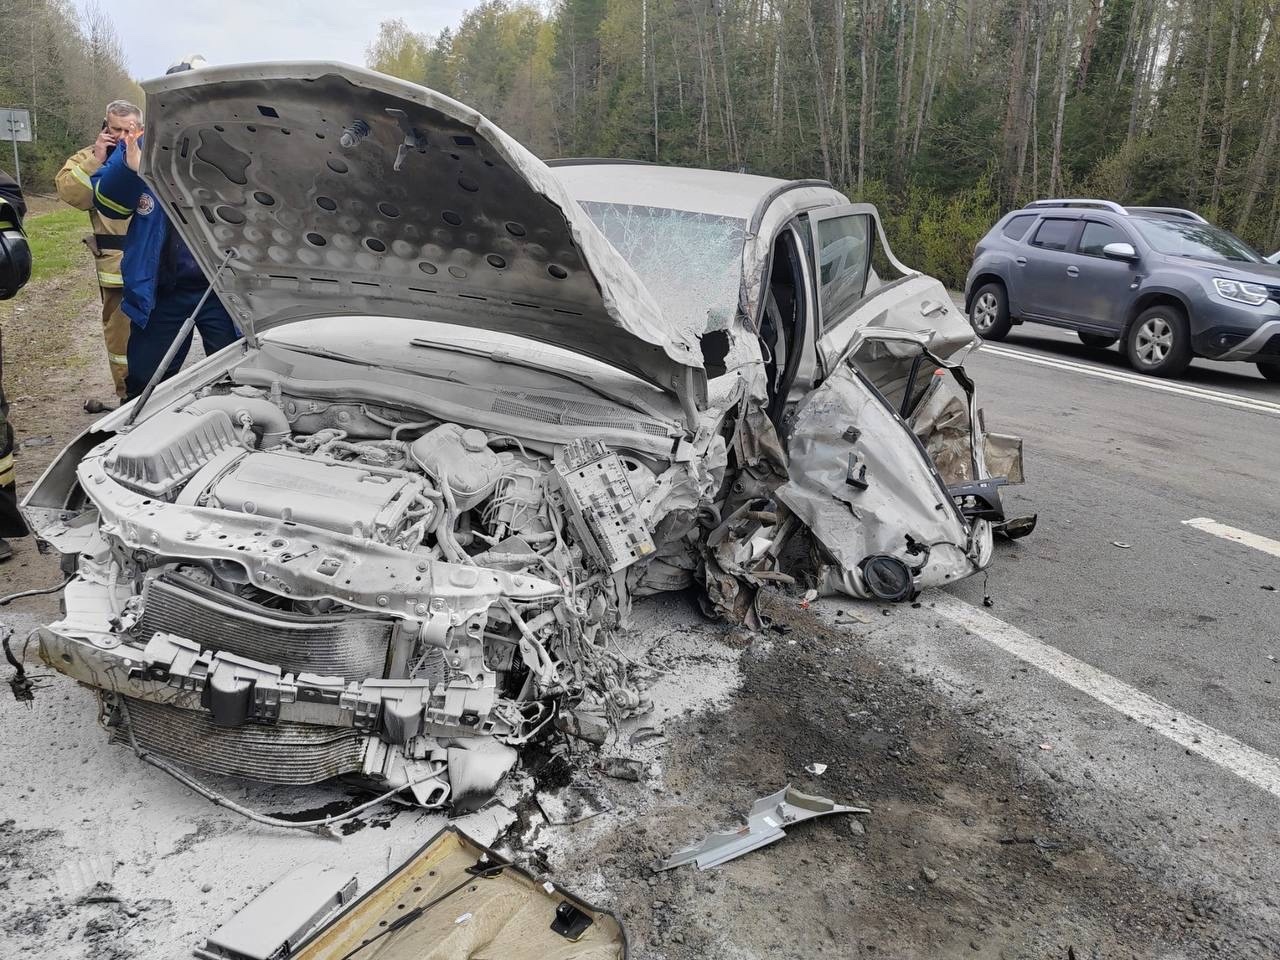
(116, 698), (364, 785)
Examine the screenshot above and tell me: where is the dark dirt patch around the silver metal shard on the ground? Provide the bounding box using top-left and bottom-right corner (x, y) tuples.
(511, 599), (1258, 960)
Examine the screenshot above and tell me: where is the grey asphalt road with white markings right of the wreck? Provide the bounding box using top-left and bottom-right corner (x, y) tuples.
(872, 317), (1280, 956)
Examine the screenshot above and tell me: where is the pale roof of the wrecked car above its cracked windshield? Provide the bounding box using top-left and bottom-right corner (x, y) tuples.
(548, 159), (804, 220)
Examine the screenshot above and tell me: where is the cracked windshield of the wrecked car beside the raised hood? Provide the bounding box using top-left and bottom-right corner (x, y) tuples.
(581, 201), (746, 337)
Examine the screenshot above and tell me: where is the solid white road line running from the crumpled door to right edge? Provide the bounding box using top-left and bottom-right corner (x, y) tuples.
(933, 594), (1280, 797)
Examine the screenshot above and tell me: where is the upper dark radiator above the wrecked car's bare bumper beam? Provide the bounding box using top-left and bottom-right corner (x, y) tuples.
(136, 579), (392, 680)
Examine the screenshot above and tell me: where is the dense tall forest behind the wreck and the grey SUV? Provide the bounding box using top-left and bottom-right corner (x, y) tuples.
(369, 0), (1280, 282)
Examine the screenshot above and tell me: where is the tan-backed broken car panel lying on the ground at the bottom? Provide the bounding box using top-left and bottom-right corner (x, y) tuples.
(292, 827), (627, 960)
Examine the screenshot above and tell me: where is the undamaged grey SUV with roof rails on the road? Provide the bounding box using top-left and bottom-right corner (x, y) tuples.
(965, 200), (1280, 383)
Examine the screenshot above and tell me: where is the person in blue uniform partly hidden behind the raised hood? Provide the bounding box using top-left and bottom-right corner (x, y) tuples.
(90, 56), (241, 399)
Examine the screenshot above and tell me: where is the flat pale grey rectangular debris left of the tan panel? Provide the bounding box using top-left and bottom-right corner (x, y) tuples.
(192, 863), (356, 960)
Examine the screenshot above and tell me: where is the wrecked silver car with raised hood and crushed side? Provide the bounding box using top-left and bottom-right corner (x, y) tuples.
(17, 64), (1021, 806)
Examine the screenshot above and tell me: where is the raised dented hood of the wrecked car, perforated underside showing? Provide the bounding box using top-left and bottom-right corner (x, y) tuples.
(142, 63), (707, 412)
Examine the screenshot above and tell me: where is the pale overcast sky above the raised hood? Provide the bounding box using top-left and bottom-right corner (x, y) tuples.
(92, 0), (479, 79)
